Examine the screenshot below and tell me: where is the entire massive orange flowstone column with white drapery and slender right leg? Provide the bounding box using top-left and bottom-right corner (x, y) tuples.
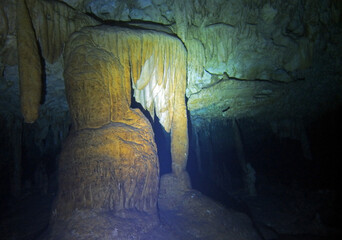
(50, 26), (188, 238)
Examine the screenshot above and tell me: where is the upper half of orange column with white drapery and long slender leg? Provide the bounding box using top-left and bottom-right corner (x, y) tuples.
(65, 26), (188, 174)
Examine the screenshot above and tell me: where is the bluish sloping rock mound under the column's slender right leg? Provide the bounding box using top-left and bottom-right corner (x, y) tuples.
(158, 174), (261, 240)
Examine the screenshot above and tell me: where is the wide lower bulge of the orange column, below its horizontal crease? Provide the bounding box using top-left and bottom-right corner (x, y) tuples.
(56, 120), (159, 218)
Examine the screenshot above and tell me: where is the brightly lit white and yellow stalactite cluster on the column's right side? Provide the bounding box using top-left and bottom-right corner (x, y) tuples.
(131, 30), (186, 132)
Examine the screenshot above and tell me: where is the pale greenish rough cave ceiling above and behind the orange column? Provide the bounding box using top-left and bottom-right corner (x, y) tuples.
(0, 0), (342, 130)
